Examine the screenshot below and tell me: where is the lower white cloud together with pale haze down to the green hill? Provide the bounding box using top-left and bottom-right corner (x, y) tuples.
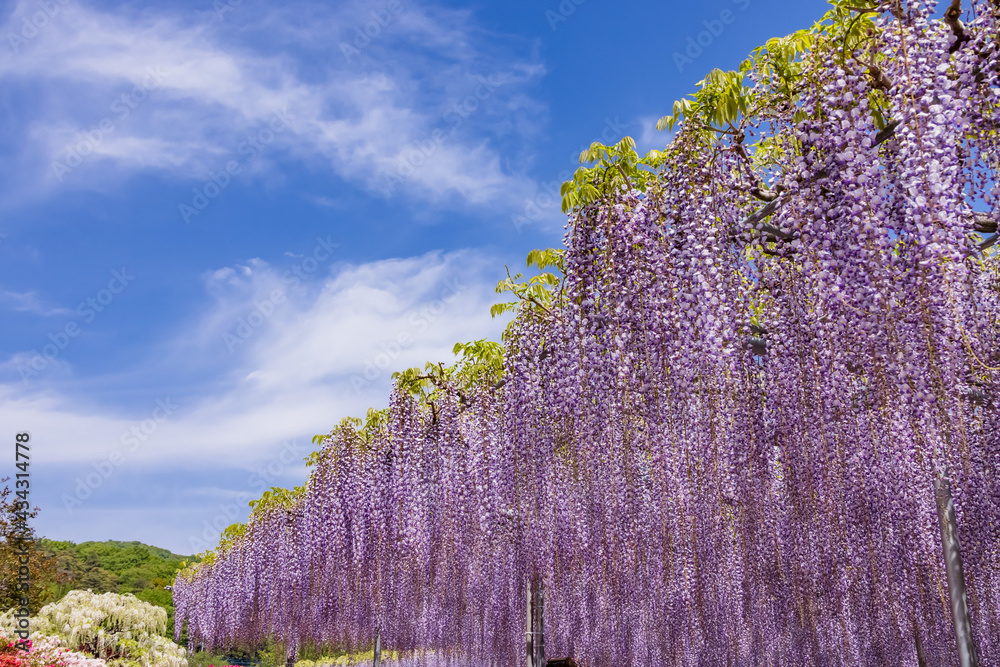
(14, 245), (504, 553)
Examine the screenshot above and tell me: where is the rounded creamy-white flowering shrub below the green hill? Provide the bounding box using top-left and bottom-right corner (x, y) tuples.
(0, 590), (187, 667)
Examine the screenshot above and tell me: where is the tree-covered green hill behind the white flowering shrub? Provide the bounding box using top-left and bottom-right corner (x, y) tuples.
(39, 539), (193, 634)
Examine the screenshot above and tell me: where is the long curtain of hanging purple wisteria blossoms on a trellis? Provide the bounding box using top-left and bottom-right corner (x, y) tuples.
(174, 0), (1000, 667)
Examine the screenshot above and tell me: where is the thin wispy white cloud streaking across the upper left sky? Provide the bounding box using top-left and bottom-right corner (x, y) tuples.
(0, 0), (542, 203)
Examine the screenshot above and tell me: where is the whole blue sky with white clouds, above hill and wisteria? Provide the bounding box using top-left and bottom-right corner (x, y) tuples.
(0, 0), (825, 554)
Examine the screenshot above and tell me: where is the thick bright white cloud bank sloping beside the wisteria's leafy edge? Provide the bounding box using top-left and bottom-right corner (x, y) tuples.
(0, 251), (501, 467)
